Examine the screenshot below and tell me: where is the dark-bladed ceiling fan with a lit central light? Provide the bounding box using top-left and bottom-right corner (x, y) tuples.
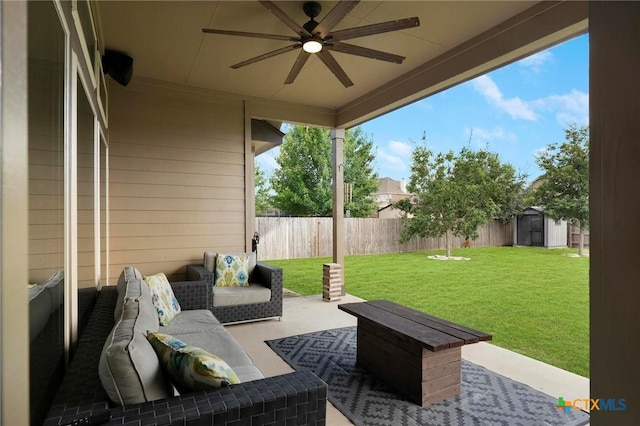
(202, 0), (420, 87)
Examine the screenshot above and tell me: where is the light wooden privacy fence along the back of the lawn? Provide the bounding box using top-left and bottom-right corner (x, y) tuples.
(256, 217), (513, 260)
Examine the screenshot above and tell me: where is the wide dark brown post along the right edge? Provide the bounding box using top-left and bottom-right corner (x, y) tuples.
(584, 1), (640, 425)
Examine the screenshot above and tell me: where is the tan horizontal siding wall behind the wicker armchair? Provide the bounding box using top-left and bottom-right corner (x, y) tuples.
(109, 81), (245, 282)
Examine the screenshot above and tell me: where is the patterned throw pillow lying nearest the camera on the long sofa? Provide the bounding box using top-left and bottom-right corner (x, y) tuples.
(147, 332), (240, 393)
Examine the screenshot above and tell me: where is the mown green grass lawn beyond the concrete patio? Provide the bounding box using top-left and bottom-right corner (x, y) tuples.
(267, 247), (589, 377)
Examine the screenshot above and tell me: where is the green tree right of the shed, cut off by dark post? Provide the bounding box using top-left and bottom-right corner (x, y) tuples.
(534, 124), (589, 256)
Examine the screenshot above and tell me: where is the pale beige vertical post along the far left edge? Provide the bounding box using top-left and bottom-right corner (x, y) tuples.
(0, 1), (29, 425)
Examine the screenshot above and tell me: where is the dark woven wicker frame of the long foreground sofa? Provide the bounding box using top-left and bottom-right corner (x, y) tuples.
(44, 281), (327, 426)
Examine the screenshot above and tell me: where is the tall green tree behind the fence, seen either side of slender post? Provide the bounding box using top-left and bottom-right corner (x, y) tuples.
(271, 126), (378, 217)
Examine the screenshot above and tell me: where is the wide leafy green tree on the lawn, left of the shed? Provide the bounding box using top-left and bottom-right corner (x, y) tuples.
(396, 141), (524, 257)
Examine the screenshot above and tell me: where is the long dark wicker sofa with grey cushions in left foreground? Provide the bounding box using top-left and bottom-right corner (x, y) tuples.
(44, 268), (327, 426)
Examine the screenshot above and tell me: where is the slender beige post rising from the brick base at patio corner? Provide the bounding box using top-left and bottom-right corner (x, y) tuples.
(331, 129), (346, 296)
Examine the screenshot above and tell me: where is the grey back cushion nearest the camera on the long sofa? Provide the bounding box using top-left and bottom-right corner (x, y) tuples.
(98, 278), (168, 405)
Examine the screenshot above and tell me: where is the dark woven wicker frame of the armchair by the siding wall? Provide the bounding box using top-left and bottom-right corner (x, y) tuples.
(187, 262), (282, 324)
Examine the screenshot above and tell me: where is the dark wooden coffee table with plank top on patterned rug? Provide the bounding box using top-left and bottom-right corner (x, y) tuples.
(338, 300), (492, 406)
